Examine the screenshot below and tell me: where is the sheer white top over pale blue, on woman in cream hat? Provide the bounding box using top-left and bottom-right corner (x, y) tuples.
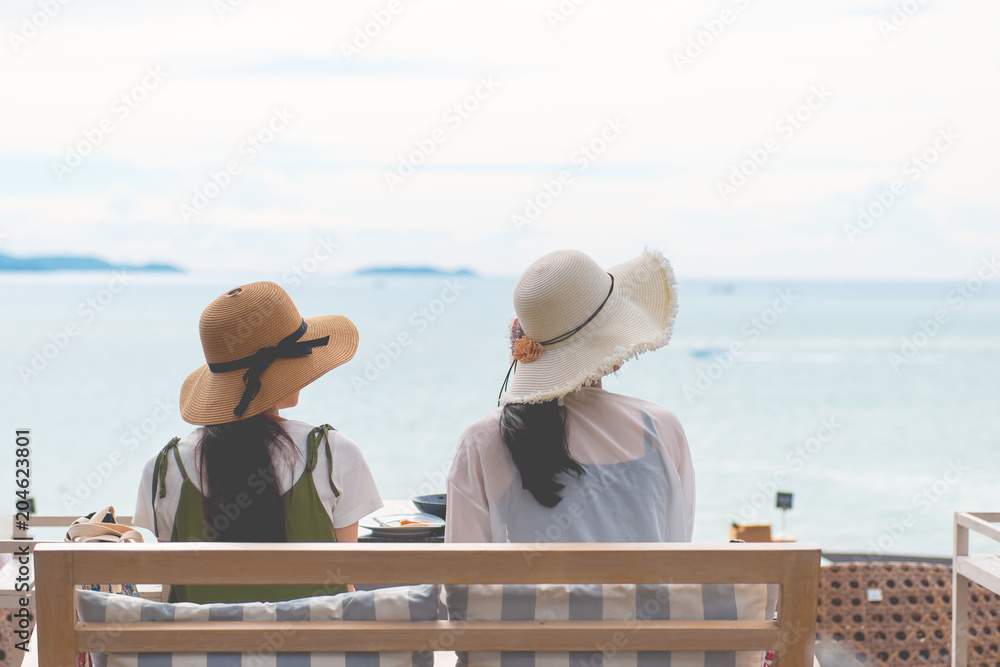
(445, 387), (695, 543)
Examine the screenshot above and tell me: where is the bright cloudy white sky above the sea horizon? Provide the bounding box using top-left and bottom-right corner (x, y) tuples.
(0, 0), (1000, 280)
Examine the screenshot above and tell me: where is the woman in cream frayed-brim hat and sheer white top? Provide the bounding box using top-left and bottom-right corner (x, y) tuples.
(445, 250), (694, 543)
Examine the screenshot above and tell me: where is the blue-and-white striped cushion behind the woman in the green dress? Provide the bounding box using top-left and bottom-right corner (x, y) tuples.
(76, 584), (440, 667)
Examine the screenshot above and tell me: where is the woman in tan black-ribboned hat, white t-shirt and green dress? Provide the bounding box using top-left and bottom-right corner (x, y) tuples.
(134, 282), (382, 602)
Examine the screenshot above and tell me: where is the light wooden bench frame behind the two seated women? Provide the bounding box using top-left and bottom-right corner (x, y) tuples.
(35, 543), (820, 667)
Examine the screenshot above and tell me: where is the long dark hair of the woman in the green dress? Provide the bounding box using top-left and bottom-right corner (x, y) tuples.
(199, 414), (295, 542)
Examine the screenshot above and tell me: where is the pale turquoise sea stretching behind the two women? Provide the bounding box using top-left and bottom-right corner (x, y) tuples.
(0, 271), (1000, 556)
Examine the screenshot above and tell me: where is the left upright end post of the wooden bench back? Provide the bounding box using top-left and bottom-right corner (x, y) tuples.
(34, 545), (77, 667)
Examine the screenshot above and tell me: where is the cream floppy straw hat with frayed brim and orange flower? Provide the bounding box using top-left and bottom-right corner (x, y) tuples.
(499, 249), (677, 405)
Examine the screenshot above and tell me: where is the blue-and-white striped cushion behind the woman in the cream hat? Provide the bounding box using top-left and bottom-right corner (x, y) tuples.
(445, 584), (777, 667)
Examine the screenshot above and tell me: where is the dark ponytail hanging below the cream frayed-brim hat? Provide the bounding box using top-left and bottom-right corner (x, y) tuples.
(500, 400), (584, 507)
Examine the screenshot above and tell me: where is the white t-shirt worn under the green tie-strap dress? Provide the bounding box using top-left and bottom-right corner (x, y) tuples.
(132, 420), (382, 540)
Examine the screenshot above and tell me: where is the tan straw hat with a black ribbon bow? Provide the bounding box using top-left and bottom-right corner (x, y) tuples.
(181, 282), (358, 426)
